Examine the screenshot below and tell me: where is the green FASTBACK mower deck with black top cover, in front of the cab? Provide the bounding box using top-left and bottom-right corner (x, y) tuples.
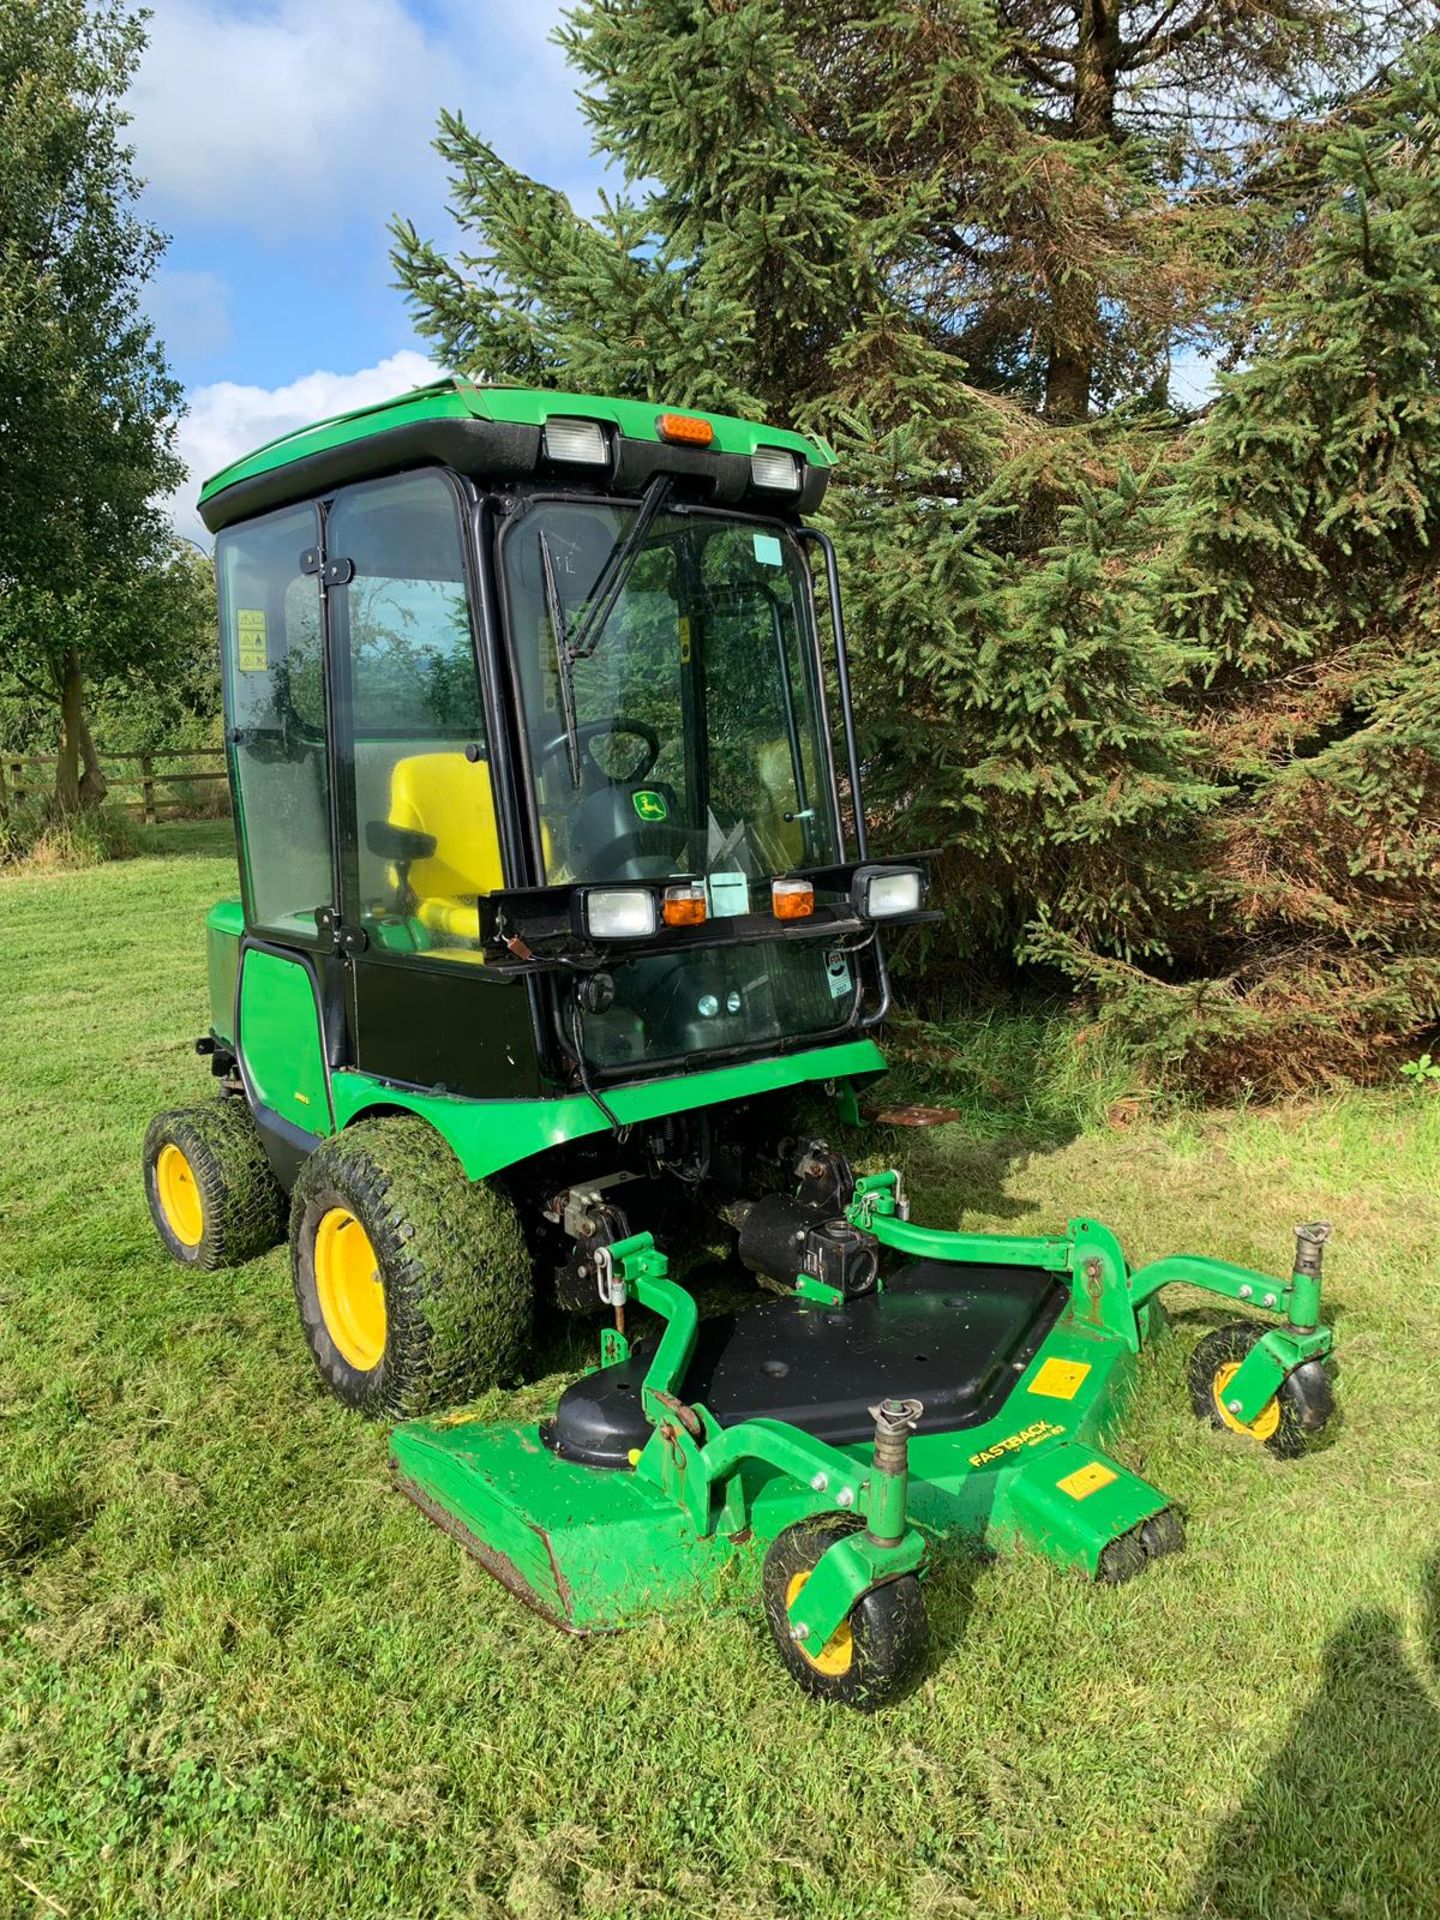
(394, 1261), (1169, 1632)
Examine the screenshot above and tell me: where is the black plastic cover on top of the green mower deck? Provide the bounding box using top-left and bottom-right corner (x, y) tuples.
(541, 1260), (1068, 1467)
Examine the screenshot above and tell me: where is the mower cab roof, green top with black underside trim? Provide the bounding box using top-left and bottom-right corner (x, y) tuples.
(200, 374), (835, 532)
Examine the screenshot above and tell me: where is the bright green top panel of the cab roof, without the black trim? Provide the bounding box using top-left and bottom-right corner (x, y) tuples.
(200, 378), (835, 505)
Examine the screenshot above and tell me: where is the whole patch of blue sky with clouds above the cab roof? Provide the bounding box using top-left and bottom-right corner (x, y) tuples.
(131, 0), (601, 532)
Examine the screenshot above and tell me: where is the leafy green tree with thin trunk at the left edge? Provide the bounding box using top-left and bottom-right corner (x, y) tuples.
(0, 0), (202, 806)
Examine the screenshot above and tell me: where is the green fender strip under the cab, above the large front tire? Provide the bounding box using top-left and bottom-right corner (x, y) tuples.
(330, 1044), (885, 1181)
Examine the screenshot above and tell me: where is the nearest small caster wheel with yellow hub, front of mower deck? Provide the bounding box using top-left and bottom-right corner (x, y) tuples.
(762, 1515), (929, 1713)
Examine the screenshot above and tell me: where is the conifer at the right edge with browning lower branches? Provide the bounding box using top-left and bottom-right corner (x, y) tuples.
(1069, 46), (1440, 1085)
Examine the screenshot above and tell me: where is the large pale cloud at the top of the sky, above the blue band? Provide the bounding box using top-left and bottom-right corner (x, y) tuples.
(131, 0), (597, 246)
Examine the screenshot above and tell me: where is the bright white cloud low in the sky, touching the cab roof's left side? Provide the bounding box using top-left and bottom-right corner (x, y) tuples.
(167, 348), (438, 540)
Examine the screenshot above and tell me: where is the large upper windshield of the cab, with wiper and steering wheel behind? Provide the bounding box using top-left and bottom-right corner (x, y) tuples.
(503, 501), (839, 883)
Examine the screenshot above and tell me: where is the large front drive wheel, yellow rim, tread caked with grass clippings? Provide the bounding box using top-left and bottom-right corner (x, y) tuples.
(290, 1119), (534, 1419)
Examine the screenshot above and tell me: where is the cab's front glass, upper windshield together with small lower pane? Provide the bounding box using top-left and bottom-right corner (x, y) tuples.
(501, 501), (858, 1069)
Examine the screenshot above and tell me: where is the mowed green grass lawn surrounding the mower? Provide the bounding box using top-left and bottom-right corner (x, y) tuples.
(0, 826), (1440, 1920)
